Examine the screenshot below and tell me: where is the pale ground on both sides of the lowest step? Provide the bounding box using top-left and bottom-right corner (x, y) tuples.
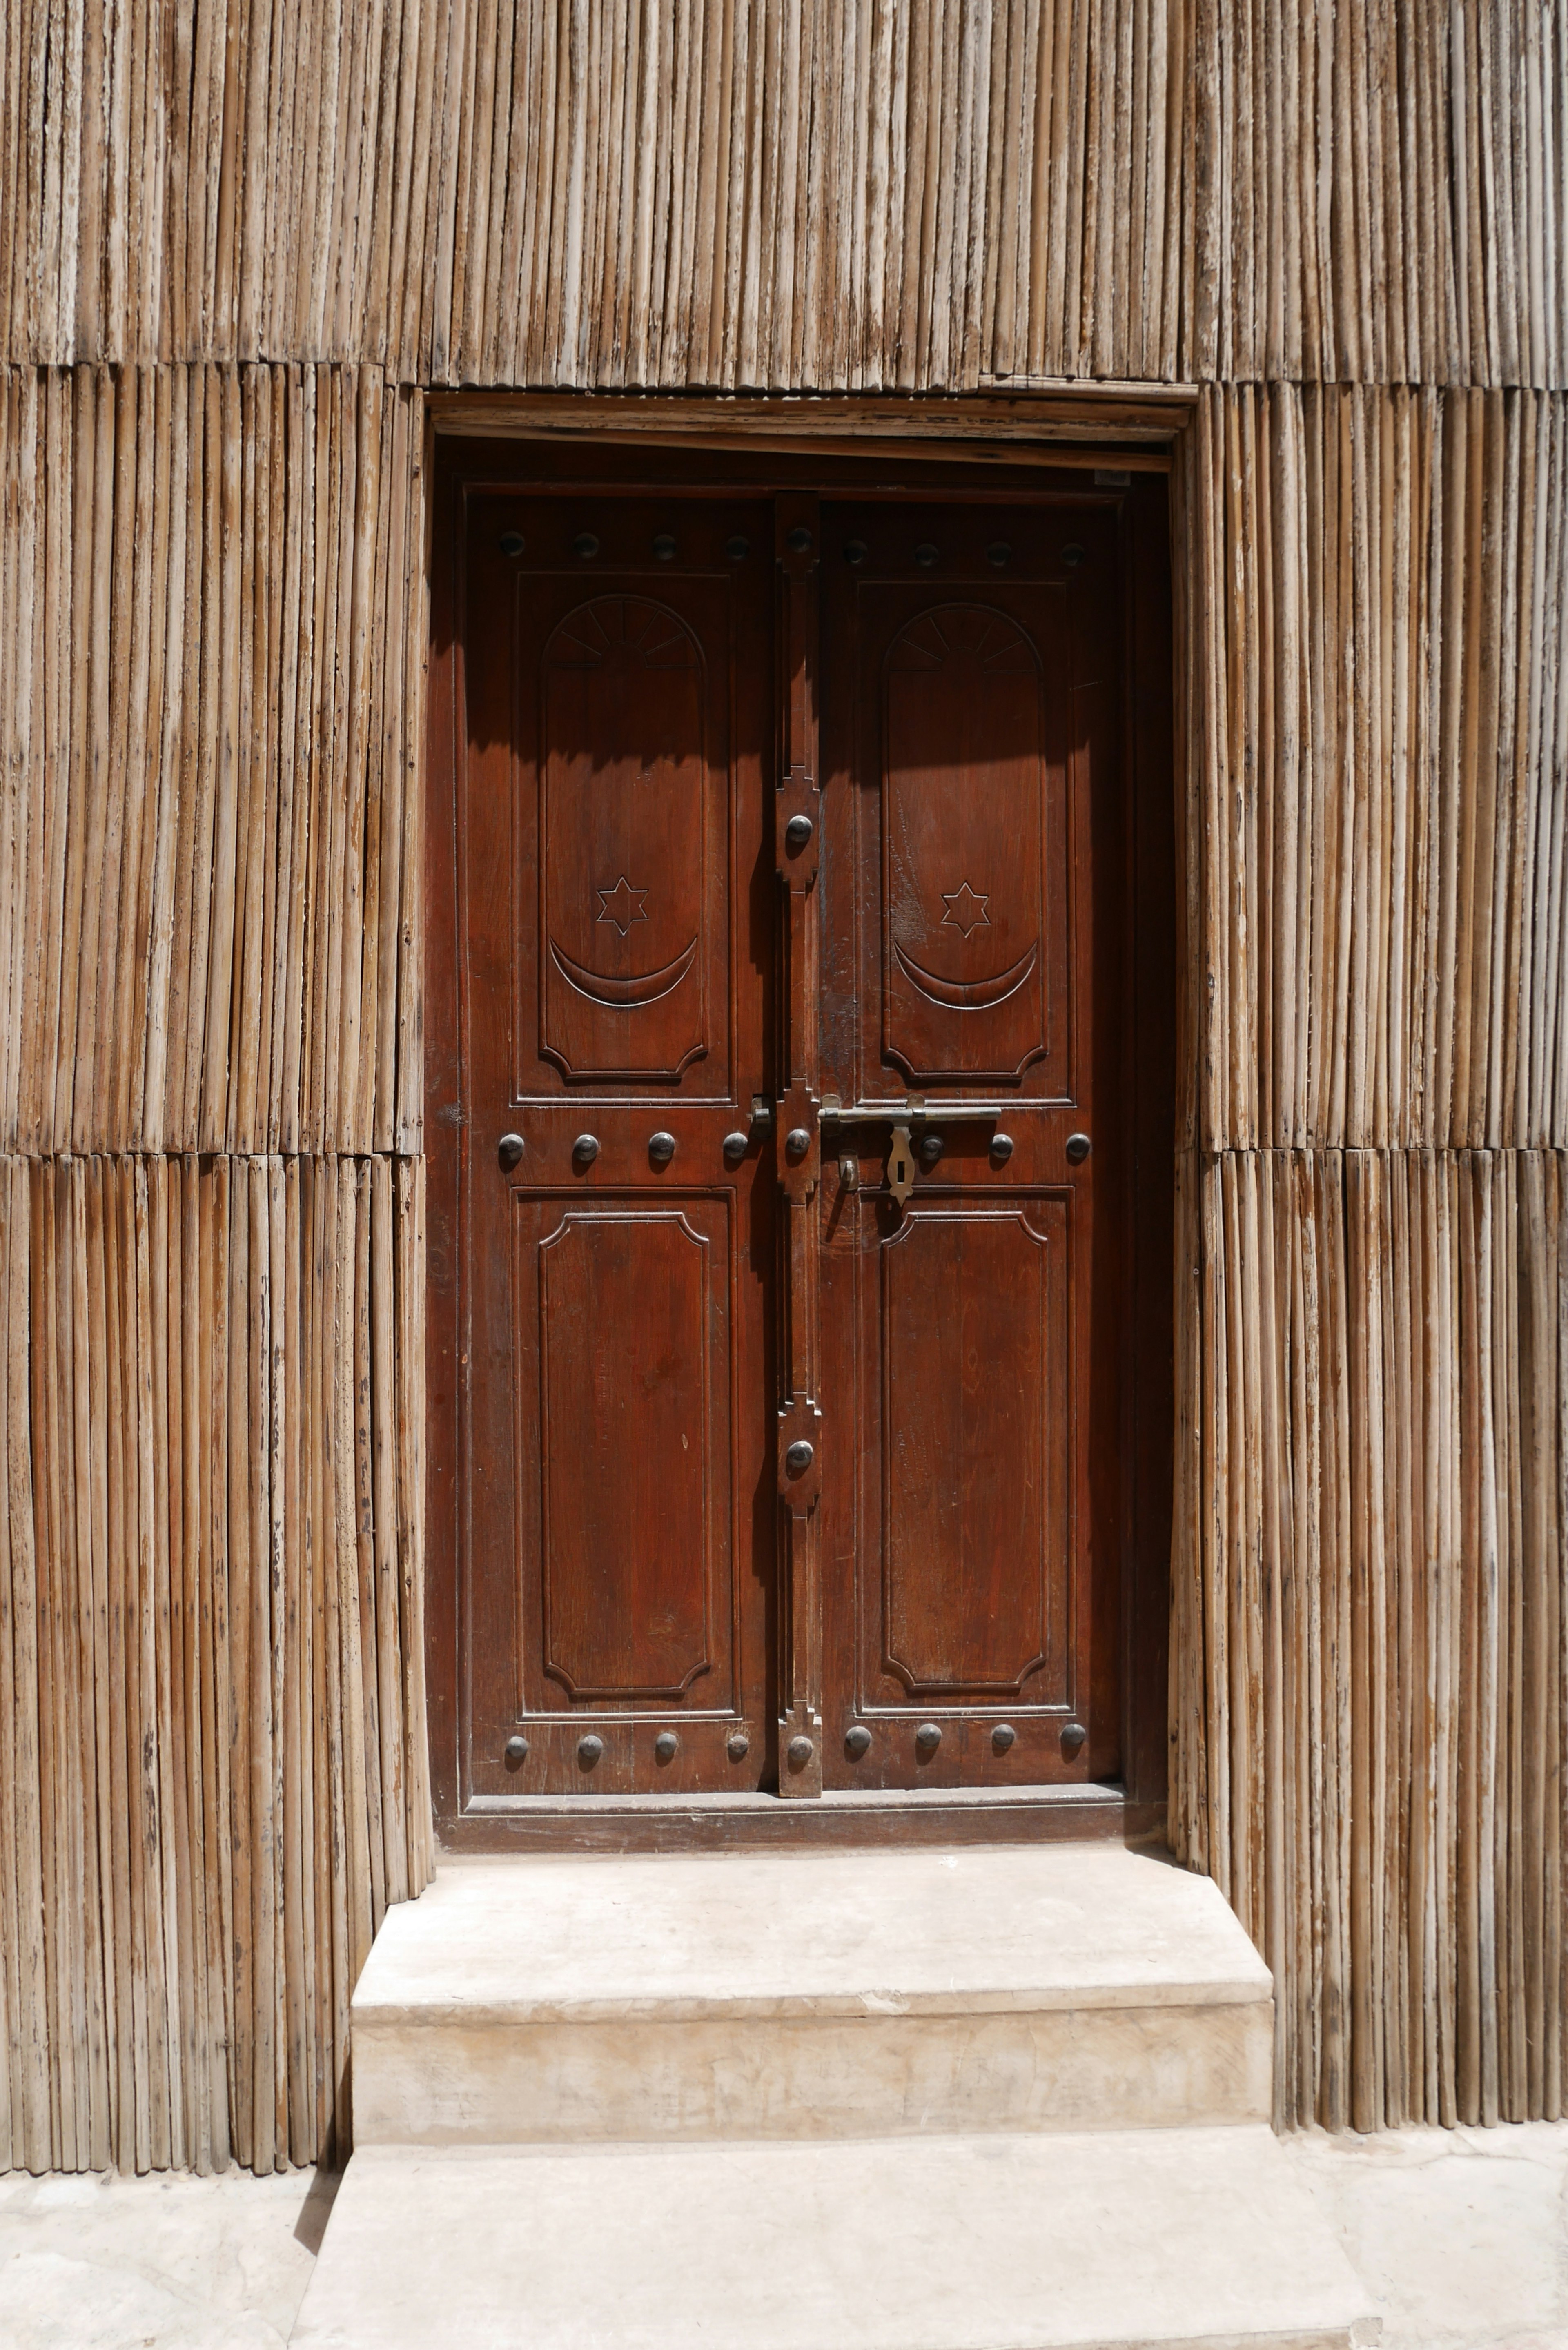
(0, 2122), (1568, 2350)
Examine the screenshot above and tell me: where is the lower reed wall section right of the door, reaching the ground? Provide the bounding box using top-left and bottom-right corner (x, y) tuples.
(1171, 1149), (1568, 2129)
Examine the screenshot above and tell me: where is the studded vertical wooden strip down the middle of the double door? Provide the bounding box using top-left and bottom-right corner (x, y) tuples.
(773, 496), (823, 1798)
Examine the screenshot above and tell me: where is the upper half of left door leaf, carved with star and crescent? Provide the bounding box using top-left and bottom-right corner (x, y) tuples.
(468, 494), (771, 1102)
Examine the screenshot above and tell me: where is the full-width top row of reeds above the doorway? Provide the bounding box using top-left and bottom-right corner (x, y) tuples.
(0, 0), (1568, 390)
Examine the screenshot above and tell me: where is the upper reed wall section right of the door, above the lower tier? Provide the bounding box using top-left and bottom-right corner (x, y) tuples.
(1185, 385), (1568, 1149)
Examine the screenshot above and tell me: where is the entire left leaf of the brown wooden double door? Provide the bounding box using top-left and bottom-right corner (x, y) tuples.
(459, 486), (776, 1809)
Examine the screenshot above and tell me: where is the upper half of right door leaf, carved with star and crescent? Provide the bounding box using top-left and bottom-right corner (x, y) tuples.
(823, 501), (1114, 1102)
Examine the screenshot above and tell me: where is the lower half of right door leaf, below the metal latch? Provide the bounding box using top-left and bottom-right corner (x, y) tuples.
(823, 1187), (1081, 1786)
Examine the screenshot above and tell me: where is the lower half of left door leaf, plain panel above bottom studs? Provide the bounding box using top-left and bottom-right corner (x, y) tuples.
(472, 1189), (764, 1800)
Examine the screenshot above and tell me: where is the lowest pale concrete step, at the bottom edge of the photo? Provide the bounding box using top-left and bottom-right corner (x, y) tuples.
(292, 2127), (1378, 2350)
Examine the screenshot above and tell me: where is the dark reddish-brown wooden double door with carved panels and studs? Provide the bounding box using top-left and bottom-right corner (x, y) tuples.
(432, 461), (1126, 1809)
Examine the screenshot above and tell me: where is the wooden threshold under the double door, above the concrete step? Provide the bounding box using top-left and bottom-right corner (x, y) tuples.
(440, 1784), (1166, 1852)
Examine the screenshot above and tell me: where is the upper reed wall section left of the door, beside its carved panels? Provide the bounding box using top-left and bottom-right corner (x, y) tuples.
(0, 367), (425, 1154)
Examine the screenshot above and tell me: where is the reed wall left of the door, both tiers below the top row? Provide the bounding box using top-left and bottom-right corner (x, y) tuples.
(0, 347), (430, 2169)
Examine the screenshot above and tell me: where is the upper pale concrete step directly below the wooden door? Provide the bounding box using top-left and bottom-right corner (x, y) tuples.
(353, 1845), (1272, 2145)
